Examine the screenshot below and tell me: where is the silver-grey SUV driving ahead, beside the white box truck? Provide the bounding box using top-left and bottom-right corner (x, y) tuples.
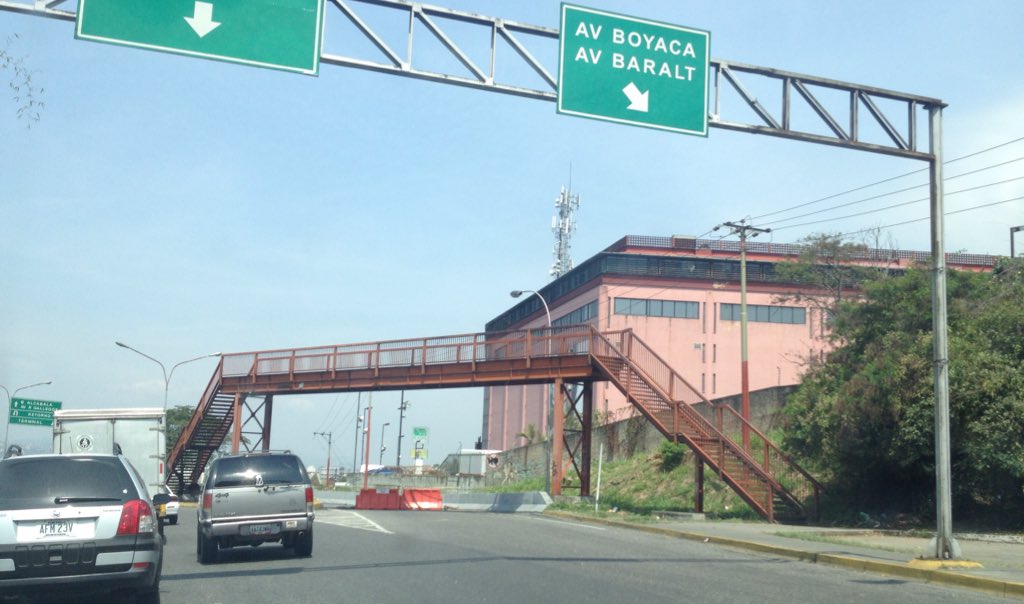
(196, 452), (315, 564)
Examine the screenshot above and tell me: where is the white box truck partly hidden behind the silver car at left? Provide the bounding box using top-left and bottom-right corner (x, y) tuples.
(53, 407), (167, 497)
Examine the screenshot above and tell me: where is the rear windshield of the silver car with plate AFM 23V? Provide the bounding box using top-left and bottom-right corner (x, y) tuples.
(0, 457), (138, 510)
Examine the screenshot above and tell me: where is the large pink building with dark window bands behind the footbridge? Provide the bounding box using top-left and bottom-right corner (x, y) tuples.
(483, 235), (995, 450)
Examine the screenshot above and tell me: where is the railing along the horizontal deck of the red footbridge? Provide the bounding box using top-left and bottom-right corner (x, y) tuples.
(221, 326), (594, 378)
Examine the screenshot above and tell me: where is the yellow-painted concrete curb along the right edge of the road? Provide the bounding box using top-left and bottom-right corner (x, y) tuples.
(545, 511), (1024, 598)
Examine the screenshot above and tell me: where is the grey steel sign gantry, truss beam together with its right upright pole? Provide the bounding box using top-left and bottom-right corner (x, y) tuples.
(0, 0), (961, 559)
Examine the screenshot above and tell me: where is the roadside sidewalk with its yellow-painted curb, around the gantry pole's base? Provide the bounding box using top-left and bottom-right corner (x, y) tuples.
(547, 511), (1024, 599)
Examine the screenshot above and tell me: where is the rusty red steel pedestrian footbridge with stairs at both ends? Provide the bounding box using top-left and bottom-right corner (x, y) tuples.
(167, 326), (822, 522)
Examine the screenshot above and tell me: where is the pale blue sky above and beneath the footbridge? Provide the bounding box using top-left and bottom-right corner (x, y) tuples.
(0, 0), (1024, 466)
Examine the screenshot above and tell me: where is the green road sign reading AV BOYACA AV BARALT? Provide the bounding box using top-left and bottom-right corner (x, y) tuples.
(558, 4), (711, 136)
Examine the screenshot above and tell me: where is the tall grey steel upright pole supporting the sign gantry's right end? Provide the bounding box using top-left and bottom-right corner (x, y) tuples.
(928, 105), (962, 560)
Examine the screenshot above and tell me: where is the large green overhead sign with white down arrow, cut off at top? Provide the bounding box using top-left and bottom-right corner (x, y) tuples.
(75, 0), (325, 76)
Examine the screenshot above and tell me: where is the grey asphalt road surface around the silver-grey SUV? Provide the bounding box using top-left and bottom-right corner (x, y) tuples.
(22, 510), (1006, 604)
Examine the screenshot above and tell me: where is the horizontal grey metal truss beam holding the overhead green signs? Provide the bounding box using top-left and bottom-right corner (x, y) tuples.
(0, 0), (945, 161)
